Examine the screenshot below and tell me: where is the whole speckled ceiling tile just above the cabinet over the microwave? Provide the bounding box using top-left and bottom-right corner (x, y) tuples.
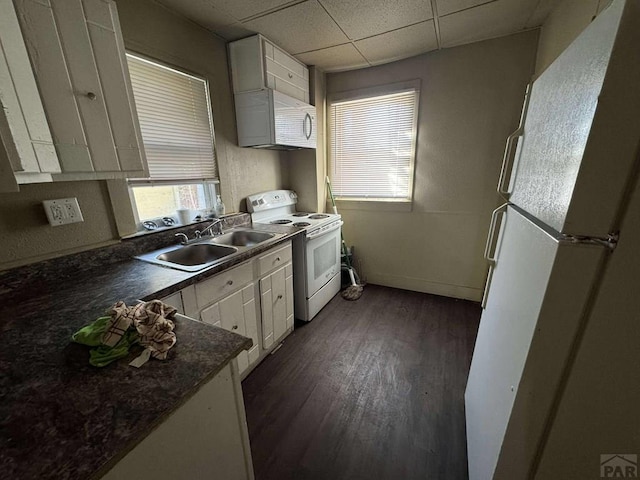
(244, 0), (349, 54)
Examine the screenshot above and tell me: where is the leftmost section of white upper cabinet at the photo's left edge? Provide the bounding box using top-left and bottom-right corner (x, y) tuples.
(0, 1), (60, 191)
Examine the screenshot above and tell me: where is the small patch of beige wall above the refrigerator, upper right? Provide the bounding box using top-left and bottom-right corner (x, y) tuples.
(535, 0), (611, 77)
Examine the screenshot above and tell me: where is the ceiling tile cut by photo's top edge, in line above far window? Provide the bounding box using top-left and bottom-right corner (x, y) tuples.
(320, 0), (433, 40)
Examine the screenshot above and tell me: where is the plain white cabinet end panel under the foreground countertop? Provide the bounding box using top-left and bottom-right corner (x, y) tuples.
(102, 360), (254, 480)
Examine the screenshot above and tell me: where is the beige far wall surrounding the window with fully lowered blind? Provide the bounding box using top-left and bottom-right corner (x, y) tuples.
(327, 31), (538, 300)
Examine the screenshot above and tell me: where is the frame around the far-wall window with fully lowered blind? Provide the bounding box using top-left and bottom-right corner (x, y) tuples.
(327, 79), (420, 212)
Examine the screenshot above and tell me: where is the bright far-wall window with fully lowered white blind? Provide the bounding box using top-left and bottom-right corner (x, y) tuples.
(329, 81), (420, 202)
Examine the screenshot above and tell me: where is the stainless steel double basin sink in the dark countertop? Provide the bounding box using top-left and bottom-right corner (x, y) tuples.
(136, 229), (284, 272)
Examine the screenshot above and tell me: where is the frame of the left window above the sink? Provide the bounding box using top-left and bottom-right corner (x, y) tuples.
(126, 49), (220, 235)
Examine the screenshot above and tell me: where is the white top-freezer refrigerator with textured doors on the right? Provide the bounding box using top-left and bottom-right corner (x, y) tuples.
(465, 0), (640, 480)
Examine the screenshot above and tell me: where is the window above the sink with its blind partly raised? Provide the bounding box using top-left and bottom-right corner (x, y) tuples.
(127, 54), (218, 223)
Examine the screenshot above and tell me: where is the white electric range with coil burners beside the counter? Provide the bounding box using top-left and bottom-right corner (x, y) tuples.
(247, 190), (342, 322)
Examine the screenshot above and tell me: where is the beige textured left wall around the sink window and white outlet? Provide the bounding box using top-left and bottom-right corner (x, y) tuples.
(0, 0), (288, 270)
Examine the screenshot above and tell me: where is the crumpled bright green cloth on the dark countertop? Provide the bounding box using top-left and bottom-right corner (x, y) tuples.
(71, 317), (140, 367)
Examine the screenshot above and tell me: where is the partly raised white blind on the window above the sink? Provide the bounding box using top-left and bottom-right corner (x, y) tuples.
(127, 54), (218, 180)
